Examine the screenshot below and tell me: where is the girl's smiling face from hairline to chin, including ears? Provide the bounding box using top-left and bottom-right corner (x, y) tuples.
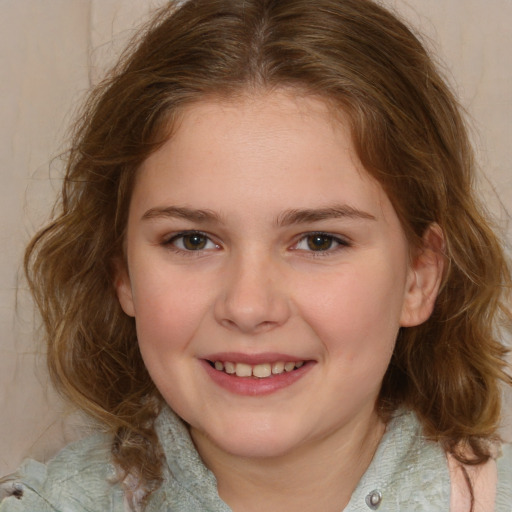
(117, 91), (440, 457)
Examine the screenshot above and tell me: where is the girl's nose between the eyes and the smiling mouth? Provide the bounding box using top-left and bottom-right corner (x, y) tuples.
(214, 256), (290, 334)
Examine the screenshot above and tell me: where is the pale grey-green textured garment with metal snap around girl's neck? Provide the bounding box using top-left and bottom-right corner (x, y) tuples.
(0, 409), (512, 512)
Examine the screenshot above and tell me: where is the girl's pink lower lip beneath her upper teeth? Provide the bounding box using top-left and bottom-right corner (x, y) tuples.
(201, 360), (314, 396)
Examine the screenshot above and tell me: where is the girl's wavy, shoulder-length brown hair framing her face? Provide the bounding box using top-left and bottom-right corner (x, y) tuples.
(25, 0), (511, 504)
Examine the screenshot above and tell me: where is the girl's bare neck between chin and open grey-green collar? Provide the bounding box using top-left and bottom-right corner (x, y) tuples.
(193, 414), (385, 512)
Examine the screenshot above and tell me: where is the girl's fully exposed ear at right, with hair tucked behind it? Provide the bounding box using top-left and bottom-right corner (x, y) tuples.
(400, 224), (445, 327)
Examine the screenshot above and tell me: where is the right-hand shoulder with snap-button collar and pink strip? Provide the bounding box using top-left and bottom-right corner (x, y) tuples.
(346, 411), (512, 512)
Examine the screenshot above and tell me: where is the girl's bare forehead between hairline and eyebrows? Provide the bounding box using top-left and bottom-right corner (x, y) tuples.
(134, 90), (392, 224)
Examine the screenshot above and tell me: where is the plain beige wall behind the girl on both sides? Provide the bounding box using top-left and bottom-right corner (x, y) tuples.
(0, 0), (512, 475)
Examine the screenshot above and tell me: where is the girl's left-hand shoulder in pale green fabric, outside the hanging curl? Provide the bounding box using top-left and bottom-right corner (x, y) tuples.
(0, 434), (122, 512)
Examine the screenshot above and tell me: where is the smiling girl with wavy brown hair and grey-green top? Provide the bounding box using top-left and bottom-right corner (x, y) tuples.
(0, 0), (512, 512)
